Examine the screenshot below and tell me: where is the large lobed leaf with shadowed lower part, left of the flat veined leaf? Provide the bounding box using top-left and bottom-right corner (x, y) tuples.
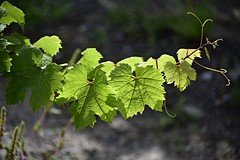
(57, 64), (116, 128)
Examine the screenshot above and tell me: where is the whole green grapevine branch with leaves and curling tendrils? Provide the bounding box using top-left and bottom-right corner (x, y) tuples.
(0, 1), (230, 128)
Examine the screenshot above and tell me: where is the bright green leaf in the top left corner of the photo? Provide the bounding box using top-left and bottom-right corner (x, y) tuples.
(0, 1), (25, 29)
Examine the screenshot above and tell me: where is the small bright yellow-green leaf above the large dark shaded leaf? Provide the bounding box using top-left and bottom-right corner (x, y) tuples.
(34, 36), (62, 57)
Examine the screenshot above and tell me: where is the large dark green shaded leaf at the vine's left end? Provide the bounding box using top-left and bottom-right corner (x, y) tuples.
(6, 45), (63, 110)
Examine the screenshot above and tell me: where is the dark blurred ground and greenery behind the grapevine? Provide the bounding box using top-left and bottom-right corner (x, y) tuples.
(0, 0), (240, 160)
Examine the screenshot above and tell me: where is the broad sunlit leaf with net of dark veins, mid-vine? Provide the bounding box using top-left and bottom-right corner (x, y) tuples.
(109, 64), (165, 118)
